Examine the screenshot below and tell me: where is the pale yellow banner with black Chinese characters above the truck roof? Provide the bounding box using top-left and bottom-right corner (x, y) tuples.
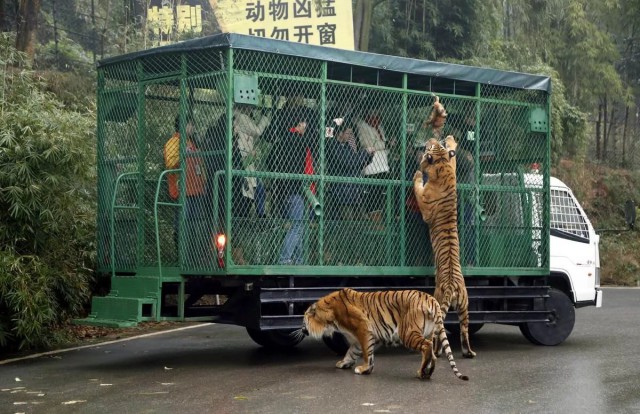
(209, 0), (354, 50)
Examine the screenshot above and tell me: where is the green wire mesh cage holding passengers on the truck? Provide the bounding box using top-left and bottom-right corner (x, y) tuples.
(98, 40), (548, 274)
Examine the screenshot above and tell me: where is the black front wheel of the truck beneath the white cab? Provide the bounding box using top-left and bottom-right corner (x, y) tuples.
(520, 288), (576, 346)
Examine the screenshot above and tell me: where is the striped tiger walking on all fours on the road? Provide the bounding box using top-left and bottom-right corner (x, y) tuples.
(298, 288), (469, 381)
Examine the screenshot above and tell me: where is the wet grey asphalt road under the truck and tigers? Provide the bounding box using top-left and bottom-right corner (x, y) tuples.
(0, 289), (640, 414)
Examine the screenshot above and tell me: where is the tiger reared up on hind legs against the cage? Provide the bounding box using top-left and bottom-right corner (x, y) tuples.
(413, 135), (476, 358)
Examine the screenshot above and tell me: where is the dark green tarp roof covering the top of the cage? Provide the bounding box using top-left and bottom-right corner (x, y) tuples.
(98, 33), (551, 93)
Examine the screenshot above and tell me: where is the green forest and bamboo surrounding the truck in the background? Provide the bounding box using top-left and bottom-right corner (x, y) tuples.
(0, 0), (640, 352)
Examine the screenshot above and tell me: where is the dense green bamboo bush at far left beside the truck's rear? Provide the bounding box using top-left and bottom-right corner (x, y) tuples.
(0, 35), (95, 348)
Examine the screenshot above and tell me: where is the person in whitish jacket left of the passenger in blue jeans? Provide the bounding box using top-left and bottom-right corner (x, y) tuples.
(233, 104), (271, 217)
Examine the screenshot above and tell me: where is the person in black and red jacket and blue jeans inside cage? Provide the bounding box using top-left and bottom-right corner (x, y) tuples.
(267, 106), (319, 265)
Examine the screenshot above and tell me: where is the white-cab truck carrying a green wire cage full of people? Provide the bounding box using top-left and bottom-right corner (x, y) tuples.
(76, 33), (602, 350)
